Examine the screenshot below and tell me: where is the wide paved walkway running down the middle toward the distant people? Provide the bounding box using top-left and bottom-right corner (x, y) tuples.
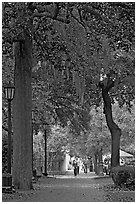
(2, 171), (112, 202)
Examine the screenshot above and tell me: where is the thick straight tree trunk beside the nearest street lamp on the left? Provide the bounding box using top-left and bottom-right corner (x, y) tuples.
(13, 33), (32, 189)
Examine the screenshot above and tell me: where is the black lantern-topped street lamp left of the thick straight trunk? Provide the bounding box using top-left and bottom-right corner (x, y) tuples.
(4, 81), (15, 174)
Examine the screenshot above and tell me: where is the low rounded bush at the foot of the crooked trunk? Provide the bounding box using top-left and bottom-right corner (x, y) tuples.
(111, 166), (135, 189)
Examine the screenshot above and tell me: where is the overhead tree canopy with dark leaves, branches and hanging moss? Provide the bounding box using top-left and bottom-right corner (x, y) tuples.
(3, 2), (135, 101)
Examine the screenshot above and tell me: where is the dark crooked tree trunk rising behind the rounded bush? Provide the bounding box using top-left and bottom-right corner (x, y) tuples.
(99, 78), (121, 167)
